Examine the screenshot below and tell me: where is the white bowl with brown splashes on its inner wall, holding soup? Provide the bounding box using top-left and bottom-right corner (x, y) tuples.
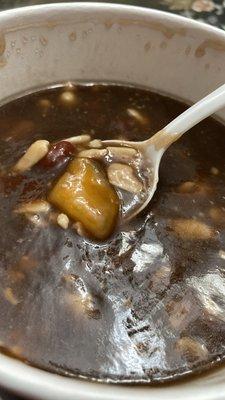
(0, 3), (225, 400)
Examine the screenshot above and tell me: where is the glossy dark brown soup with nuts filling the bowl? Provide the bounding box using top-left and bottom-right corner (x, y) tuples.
(0, 85), (225, 382)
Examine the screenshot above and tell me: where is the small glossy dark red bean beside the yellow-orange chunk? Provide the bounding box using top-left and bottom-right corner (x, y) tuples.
(39, 140), (75, 168)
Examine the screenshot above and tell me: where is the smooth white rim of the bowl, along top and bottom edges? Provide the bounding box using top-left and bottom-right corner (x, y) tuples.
(0, 2), (225, 400)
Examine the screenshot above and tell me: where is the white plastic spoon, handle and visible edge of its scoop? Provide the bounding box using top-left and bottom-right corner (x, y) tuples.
(104, 84), (225, 219)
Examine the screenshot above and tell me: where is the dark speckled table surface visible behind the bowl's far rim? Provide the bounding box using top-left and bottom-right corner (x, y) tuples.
(0, 0), (225, 400)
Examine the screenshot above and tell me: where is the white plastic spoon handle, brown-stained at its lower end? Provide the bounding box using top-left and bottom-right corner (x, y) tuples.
(156, 84), (225, 148)
